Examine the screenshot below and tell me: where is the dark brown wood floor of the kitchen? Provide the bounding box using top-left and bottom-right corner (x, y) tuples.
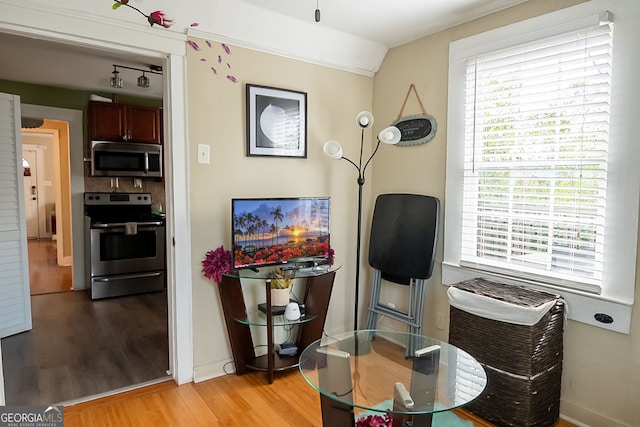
(2, 239), (169, 405)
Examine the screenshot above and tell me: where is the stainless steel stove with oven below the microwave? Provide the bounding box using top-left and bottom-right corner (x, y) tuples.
(84, 193), (166, 299)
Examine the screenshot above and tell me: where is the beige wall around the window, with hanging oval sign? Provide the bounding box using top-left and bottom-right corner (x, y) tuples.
(372, 0), (640, 427)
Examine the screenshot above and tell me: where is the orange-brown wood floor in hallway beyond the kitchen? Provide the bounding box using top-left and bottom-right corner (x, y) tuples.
(28, 239), (73, 295)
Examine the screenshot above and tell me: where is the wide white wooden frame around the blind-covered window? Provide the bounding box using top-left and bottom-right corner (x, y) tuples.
(442, 0), (640, 333)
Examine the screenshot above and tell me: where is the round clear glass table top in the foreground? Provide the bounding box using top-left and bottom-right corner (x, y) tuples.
(299, 330), (487, 414)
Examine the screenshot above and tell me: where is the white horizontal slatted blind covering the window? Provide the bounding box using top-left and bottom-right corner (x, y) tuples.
(460, 21), (612, 293)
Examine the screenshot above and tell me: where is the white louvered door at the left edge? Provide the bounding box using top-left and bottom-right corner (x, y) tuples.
(0, 93), (31, 342)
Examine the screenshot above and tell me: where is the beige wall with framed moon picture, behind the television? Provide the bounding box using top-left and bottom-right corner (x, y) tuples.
(187, 39), (376, 380)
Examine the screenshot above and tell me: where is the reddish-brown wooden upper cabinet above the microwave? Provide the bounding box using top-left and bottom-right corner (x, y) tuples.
(89, 101), (162, 144)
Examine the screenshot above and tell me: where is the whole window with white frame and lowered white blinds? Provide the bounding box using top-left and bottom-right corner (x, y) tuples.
(443, 3), (640, 334)
